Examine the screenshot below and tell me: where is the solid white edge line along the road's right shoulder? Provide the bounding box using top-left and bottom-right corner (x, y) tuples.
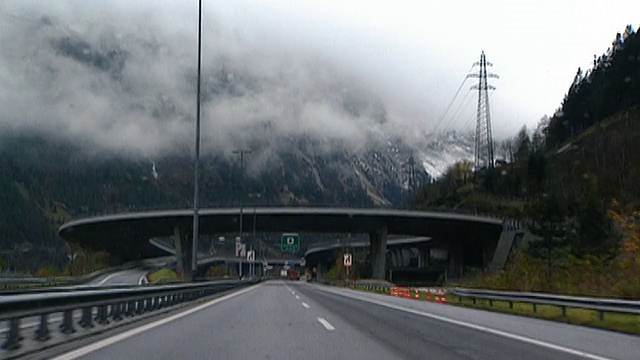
(318, 286), (613, 360)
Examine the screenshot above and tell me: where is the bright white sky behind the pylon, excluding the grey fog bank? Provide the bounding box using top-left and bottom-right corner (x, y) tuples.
(221, 0), (640, 136)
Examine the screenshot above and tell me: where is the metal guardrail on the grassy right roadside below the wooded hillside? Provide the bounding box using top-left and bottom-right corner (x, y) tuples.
(449, 288), (640, 321)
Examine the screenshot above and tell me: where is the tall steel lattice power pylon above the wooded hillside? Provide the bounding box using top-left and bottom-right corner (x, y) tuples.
(467, 51), (498, 171)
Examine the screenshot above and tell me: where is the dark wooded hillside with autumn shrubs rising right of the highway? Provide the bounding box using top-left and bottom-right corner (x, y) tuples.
(412, 23), (640, 298)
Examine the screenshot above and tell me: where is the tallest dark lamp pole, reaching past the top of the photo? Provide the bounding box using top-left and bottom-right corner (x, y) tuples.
(190, 0), (202, 280)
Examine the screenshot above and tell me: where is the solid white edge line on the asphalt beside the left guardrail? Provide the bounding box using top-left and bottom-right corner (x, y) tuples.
(51, 283), (262, 360)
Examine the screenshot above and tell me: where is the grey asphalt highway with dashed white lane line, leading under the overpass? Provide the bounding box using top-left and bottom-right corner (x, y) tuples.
(48, 281), (640, 360)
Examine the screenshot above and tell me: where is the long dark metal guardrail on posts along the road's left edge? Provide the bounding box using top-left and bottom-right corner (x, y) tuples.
(0, 280), (257, 350)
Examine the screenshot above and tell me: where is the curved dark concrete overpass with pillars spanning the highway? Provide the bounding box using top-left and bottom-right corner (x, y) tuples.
(59, 207), (504, 279)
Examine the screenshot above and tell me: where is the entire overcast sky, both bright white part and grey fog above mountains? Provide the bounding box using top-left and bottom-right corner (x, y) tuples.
(0, 0), (640, 153)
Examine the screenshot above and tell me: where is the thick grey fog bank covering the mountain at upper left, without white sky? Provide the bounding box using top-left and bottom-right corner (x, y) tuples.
(0, 1), (438, 165)
